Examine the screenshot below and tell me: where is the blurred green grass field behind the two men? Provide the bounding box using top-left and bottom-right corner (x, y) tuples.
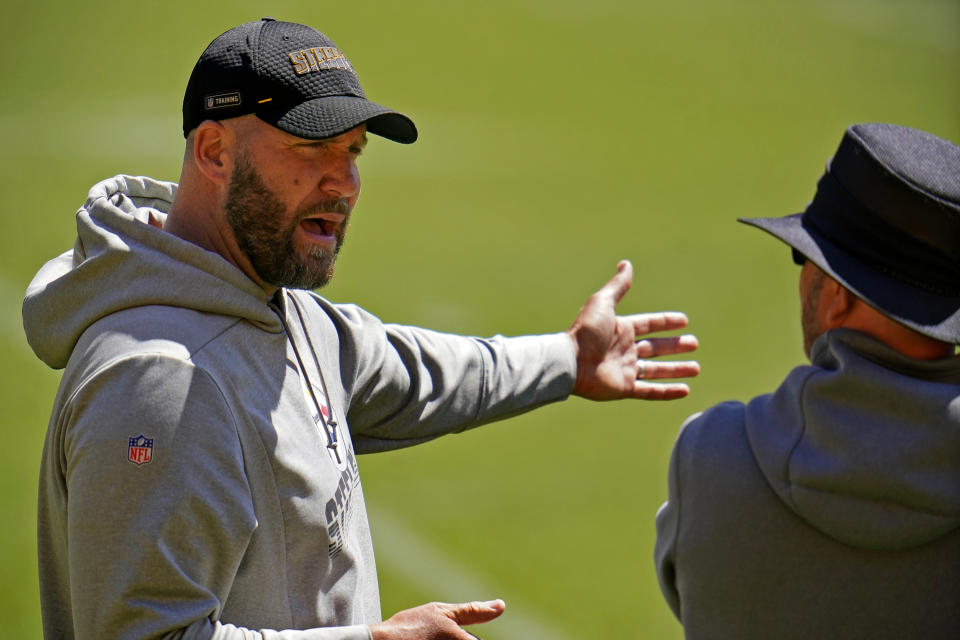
(0, 0), (960, 640)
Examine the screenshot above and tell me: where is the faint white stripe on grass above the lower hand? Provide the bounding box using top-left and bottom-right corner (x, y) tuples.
(367, 503), (569, 640)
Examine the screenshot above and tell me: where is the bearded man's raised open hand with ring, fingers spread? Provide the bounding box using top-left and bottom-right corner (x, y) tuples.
(567, 260), (700, 400)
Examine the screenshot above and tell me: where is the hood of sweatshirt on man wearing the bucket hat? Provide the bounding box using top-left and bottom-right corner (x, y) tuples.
(746, 329), (960, 549)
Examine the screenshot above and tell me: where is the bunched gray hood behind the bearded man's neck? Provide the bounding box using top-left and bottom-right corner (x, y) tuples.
(23, 175), (282, 369)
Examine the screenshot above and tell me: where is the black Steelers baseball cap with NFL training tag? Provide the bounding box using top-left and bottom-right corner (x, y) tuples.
(183, 18), (417, 144)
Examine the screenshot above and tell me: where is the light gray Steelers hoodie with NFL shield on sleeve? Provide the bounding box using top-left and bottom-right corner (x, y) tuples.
(23, 176), (576, 640)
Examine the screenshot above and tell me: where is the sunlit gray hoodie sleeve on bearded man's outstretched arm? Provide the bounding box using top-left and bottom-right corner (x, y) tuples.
(317, 299), (577, 453)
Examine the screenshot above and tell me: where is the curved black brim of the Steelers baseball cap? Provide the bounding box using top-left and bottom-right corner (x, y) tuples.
(256, 96), (417, 144)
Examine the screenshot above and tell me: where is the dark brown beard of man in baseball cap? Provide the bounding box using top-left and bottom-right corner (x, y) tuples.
(224, 154), (350, 289)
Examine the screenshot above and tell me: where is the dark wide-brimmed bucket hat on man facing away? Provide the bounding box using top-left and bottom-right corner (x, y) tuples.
(739, 124), (960, 344)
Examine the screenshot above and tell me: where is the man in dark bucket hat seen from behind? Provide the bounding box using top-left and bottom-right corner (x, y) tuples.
(655, 124), (960, 640)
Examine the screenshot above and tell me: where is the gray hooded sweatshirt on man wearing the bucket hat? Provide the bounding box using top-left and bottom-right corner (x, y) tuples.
(655, 329), (960, 640)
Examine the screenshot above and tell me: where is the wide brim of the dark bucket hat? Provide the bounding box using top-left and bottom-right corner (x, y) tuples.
(738, 213), (960, 344)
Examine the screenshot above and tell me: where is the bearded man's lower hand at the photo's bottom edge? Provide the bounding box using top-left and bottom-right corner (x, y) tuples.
(370, 600), (506, 640)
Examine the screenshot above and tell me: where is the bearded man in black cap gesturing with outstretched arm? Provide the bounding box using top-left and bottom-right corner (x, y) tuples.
(23, 19), (698, 640)
